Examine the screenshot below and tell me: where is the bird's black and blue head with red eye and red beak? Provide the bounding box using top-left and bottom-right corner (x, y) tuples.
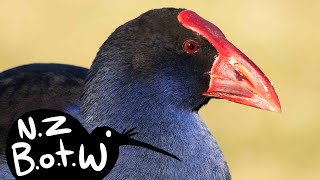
(84, 8), (281, 112)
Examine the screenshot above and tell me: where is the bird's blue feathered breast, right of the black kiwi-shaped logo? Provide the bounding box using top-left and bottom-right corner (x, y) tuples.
(100, 113), (230, 180)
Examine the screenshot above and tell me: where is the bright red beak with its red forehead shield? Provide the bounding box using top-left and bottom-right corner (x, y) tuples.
(178, 10), (281, 112)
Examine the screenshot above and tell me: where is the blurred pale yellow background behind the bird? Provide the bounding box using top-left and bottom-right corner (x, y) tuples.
(0, 0), (320, 180)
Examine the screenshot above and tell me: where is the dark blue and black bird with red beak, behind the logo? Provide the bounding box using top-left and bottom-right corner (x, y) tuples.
(0, 8), (281, 180)
